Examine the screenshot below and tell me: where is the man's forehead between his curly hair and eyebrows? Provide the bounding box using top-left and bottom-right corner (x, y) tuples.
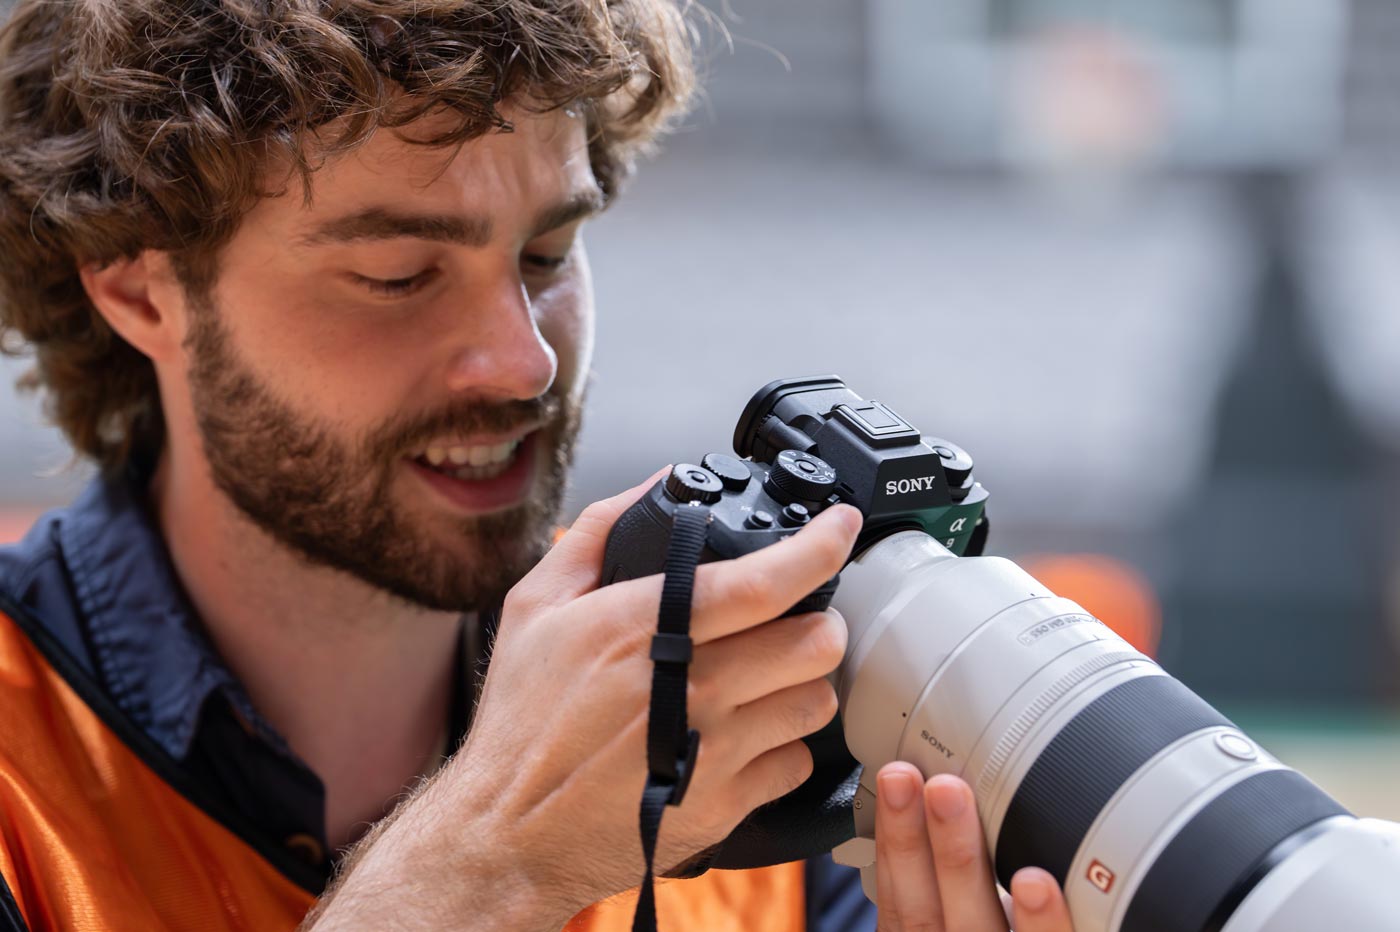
(245, 105), (598, 238)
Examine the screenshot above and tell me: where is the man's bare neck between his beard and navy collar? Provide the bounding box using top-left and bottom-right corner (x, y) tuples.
(151, 453), (461, 847)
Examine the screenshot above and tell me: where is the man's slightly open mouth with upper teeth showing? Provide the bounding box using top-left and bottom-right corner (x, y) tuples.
(407, 430), (540, 514)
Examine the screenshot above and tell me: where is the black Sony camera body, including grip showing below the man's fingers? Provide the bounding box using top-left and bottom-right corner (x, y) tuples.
(602, 375), (987, 869)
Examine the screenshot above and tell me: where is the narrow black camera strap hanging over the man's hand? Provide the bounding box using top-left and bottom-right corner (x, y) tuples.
(631, 502), (710, 932)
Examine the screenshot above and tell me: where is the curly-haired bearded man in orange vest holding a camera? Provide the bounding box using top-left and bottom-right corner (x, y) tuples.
(0, 0), (1068, 932)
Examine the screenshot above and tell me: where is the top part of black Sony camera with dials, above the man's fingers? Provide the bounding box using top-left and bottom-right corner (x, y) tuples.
(602, 375), (987, 584)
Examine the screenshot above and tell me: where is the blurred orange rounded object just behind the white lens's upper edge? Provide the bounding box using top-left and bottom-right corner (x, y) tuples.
(1018, 553), (1162, 656)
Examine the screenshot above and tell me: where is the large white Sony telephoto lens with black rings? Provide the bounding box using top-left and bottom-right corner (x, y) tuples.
(833, 532), (1400, 932)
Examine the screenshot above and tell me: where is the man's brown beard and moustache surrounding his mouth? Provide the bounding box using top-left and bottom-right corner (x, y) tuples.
(186, 302), (582, 612)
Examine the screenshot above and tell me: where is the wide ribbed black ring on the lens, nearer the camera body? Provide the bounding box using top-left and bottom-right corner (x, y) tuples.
(997, 676), (1231, 887)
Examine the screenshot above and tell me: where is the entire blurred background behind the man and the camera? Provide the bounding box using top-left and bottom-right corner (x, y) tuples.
(0, 0), (1400, 819)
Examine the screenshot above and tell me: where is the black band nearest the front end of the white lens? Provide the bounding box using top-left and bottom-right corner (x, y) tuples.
(1121, 770), (1348, 932)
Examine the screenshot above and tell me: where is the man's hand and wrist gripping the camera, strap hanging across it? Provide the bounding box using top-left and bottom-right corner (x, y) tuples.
(308, 473), (861, 931)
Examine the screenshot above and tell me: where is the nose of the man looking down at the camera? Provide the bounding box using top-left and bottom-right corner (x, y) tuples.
(447, 272), (559, 400)
